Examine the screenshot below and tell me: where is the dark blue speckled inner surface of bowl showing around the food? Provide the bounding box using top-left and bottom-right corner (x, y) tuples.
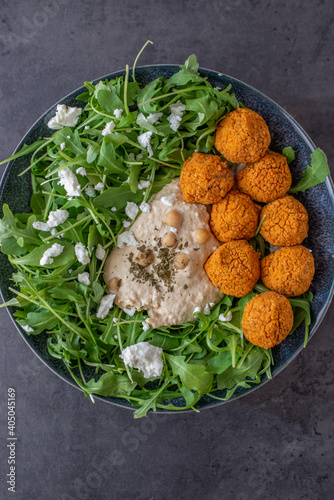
(0, 65), (334, 413)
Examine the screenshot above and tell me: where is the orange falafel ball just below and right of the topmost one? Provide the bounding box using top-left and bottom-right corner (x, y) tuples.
(236, 151), (292, 203)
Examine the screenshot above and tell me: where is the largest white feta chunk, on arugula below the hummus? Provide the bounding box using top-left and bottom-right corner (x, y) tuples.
(120, 342), (163, 378)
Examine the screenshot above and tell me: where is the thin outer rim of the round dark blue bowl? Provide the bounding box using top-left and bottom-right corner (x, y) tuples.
(0, 64), (334, 415)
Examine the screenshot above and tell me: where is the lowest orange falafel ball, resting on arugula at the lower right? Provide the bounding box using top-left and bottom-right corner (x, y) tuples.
(241, 292), (293, 349)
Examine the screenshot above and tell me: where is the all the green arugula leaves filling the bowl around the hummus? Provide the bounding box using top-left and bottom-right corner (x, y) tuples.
(0, 45), (329, 417)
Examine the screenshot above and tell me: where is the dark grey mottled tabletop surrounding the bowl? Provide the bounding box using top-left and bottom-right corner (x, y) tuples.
(0, 0), (334, 500)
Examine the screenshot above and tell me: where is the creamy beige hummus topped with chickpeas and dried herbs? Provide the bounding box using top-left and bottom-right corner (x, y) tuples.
(104, 179), (222, 327)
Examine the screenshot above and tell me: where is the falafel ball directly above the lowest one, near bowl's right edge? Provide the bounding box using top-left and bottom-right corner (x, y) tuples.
(260, 245), (315, 297)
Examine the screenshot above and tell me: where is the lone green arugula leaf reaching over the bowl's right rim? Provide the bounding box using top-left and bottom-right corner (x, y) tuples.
(289, 148), (330, 194)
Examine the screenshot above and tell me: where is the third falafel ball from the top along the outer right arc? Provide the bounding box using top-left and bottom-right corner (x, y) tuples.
(260, 196), (308, 247)
